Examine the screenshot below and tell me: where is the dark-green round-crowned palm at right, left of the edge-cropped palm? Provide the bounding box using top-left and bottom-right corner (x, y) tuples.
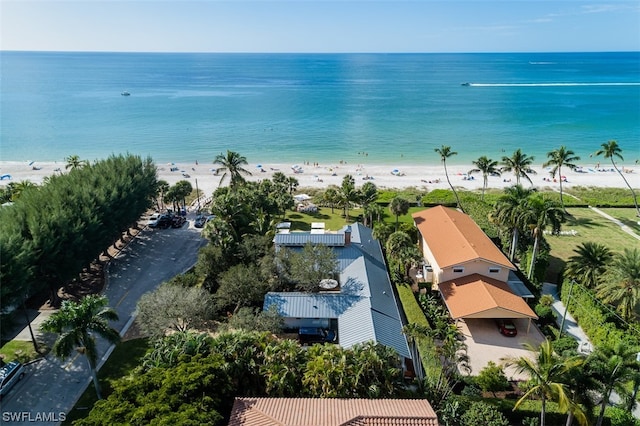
(567, 241), (613, 288)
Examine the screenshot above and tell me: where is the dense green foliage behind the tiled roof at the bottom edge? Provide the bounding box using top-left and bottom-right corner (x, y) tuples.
(78, 332), (408, 425)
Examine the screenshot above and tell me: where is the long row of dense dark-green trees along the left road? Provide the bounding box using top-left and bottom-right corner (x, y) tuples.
(0, 155), (156, 306)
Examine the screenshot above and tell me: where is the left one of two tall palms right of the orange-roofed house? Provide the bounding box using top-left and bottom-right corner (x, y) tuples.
(492, 185), (536, 262)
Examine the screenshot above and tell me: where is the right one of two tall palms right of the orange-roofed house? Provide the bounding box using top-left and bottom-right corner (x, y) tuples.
(522, 194), (565, 279)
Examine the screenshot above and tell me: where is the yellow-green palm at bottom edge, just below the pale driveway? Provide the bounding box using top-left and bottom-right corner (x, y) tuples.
(503, 339), (584, 426)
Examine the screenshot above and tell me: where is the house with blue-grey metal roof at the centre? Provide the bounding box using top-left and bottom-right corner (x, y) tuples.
(264, 223), (419, 376)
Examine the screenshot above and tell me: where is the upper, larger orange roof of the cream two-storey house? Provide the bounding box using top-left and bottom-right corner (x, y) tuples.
(412, 206), (516, 271)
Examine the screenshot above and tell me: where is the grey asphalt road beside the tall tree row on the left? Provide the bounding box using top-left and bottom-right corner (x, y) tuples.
(0, 220), (206, 425)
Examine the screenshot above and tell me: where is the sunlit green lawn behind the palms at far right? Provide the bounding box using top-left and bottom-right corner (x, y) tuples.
(545, 207), (638, 281)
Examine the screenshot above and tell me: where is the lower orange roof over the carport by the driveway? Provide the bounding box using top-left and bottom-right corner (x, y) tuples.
(438, 274), (538, 319)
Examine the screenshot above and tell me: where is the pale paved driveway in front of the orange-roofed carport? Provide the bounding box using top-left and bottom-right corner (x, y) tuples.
(458, 319), (544, 380)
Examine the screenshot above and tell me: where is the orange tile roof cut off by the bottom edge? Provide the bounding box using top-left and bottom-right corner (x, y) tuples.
(229, 398), (438, 426)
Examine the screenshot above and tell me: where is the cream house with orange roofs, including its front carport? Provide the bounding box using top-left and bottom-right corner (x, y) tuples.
(413, 206), (538, 319)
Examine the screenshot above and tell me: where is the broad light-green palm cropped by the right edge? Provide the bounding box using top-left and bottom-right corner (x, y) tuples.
(597, 247), (640, 320)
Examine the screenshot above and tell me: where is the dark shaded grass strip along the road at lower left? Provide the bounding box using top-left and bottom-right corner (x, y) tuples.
(63, 339), (150, 425)
